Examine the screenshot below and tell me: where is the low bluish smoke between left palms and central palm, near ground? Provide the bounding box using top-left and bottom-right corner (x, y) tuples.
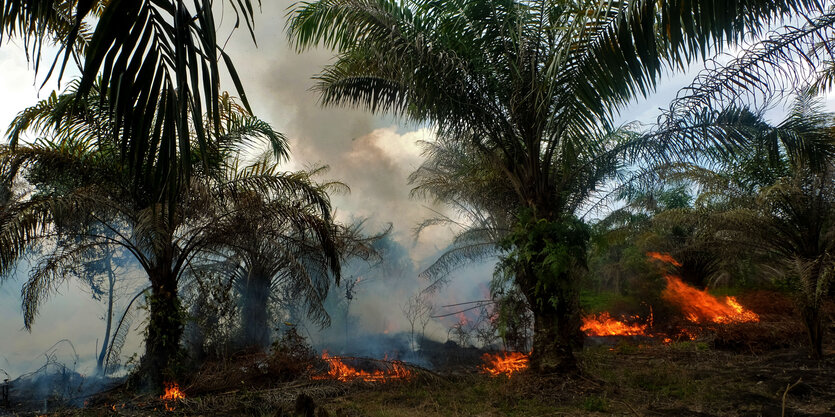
(302, 232), (493, 365)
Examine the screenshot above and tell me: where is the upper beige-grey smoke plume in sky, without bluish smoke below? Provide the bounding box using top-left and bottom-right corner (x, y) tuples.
(219, 0), (458, 262)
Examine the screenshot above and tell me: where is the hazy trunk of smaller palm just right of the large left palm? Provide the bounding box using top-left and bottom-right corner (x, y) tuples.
(241, 273), (270, 350)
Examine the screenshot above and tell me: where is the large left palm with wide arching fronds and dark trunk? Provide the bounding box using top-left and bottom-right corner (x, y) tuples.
(0, 80), (339, 389)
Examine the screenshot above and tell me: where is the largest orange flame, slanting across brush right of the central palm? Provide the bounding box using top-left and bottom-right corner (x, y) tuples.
(661, 275), (760, 324)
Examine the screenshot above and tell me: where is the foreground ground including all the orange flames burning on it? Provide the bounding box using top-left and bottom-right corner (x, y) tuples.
(0, 253), (835, 417)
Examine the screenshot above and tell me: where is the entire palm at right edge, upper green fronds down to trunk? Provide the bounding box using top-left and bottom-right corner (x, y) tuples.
(671, 95), (835, 358)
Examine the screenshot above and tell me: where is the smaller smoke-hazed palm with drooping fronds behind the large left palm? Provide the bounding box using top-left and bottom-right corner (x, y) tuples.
(189, 155), (377, 350)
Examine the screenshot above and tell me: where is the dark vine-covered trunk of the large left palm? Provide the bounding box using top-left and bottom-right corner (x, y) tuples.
(143, 262), (183, 390)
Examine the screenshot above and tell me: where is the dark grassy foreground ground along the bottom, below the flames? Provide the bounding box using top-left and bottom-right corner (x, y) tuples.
(8, 341), (835, 417)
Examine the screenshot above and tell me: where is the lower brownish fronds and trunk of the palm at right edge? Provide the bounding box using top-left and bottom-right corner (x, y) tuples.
(717, 171), (835, 359)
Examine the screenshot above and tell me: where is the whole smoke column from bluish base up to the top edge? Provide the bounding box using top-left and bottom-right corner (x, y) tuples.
(220, 0), (500, 356)
